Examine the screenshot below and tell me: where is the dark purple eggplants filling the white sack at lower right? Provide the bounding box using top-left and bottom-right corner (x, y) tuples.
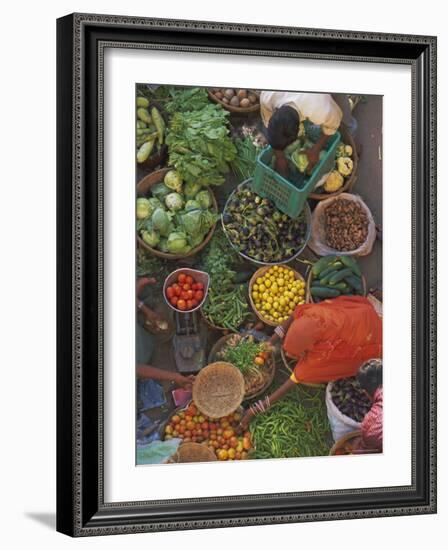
(331, 378), (372, 422)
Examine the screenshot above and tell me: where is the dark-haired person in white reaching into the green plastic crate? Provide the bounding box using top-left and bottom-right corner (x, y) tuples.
(260, 92), (343, 176)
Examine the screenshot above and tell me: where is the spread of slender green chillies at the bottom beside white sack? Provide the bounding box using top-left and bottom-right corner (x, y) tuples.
(250, 387), (330, 458)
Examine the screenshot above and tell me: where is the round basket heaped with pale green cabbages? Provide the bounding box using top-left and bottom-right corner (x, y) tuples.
(136, 168), (219, 260)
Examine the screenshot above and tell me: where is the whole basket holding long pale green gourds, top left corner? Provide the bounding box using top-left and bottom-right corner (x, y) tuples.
(136, 96), (168, 171)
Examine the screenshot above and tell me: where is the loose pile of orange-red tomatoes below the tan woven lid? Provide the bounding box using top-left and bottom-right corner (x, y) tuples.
(165, 403), (252, 460)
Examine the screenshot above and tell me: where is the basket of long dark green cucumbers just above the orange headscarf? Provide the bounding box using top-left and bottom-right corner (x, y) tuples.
(306, 255), (367, 303)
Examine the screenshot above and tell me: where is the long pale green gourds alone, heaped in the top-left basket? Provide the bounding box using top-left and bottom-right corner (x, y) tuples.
(136, 96), (165, 164)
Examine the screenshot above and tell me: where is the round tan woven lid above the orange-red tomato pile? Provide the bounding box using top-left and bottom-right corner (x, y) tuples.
(193, 361), (244, 418)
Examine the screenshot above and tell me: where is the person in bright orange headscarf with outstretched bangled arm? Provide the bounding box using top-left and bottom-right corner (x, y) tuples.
(241, 296), (383, 428)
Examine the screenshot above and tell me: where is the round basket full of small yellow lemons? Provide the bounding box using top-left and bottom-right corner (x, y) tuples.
(249, 265), (306, 327)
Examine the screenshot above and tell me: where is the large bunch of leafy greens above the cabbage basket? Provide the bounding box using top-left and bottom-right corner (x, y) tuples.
(166, 104), (236, 186)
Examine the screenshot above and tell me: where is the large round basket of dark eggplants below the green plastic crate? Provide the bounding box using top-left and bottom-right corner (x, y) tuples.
(221, 179), (311, 265)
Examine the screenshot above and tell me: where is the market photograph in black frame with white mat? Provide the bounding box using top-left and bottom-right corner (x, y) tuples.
(57, 14), (436, 536)
